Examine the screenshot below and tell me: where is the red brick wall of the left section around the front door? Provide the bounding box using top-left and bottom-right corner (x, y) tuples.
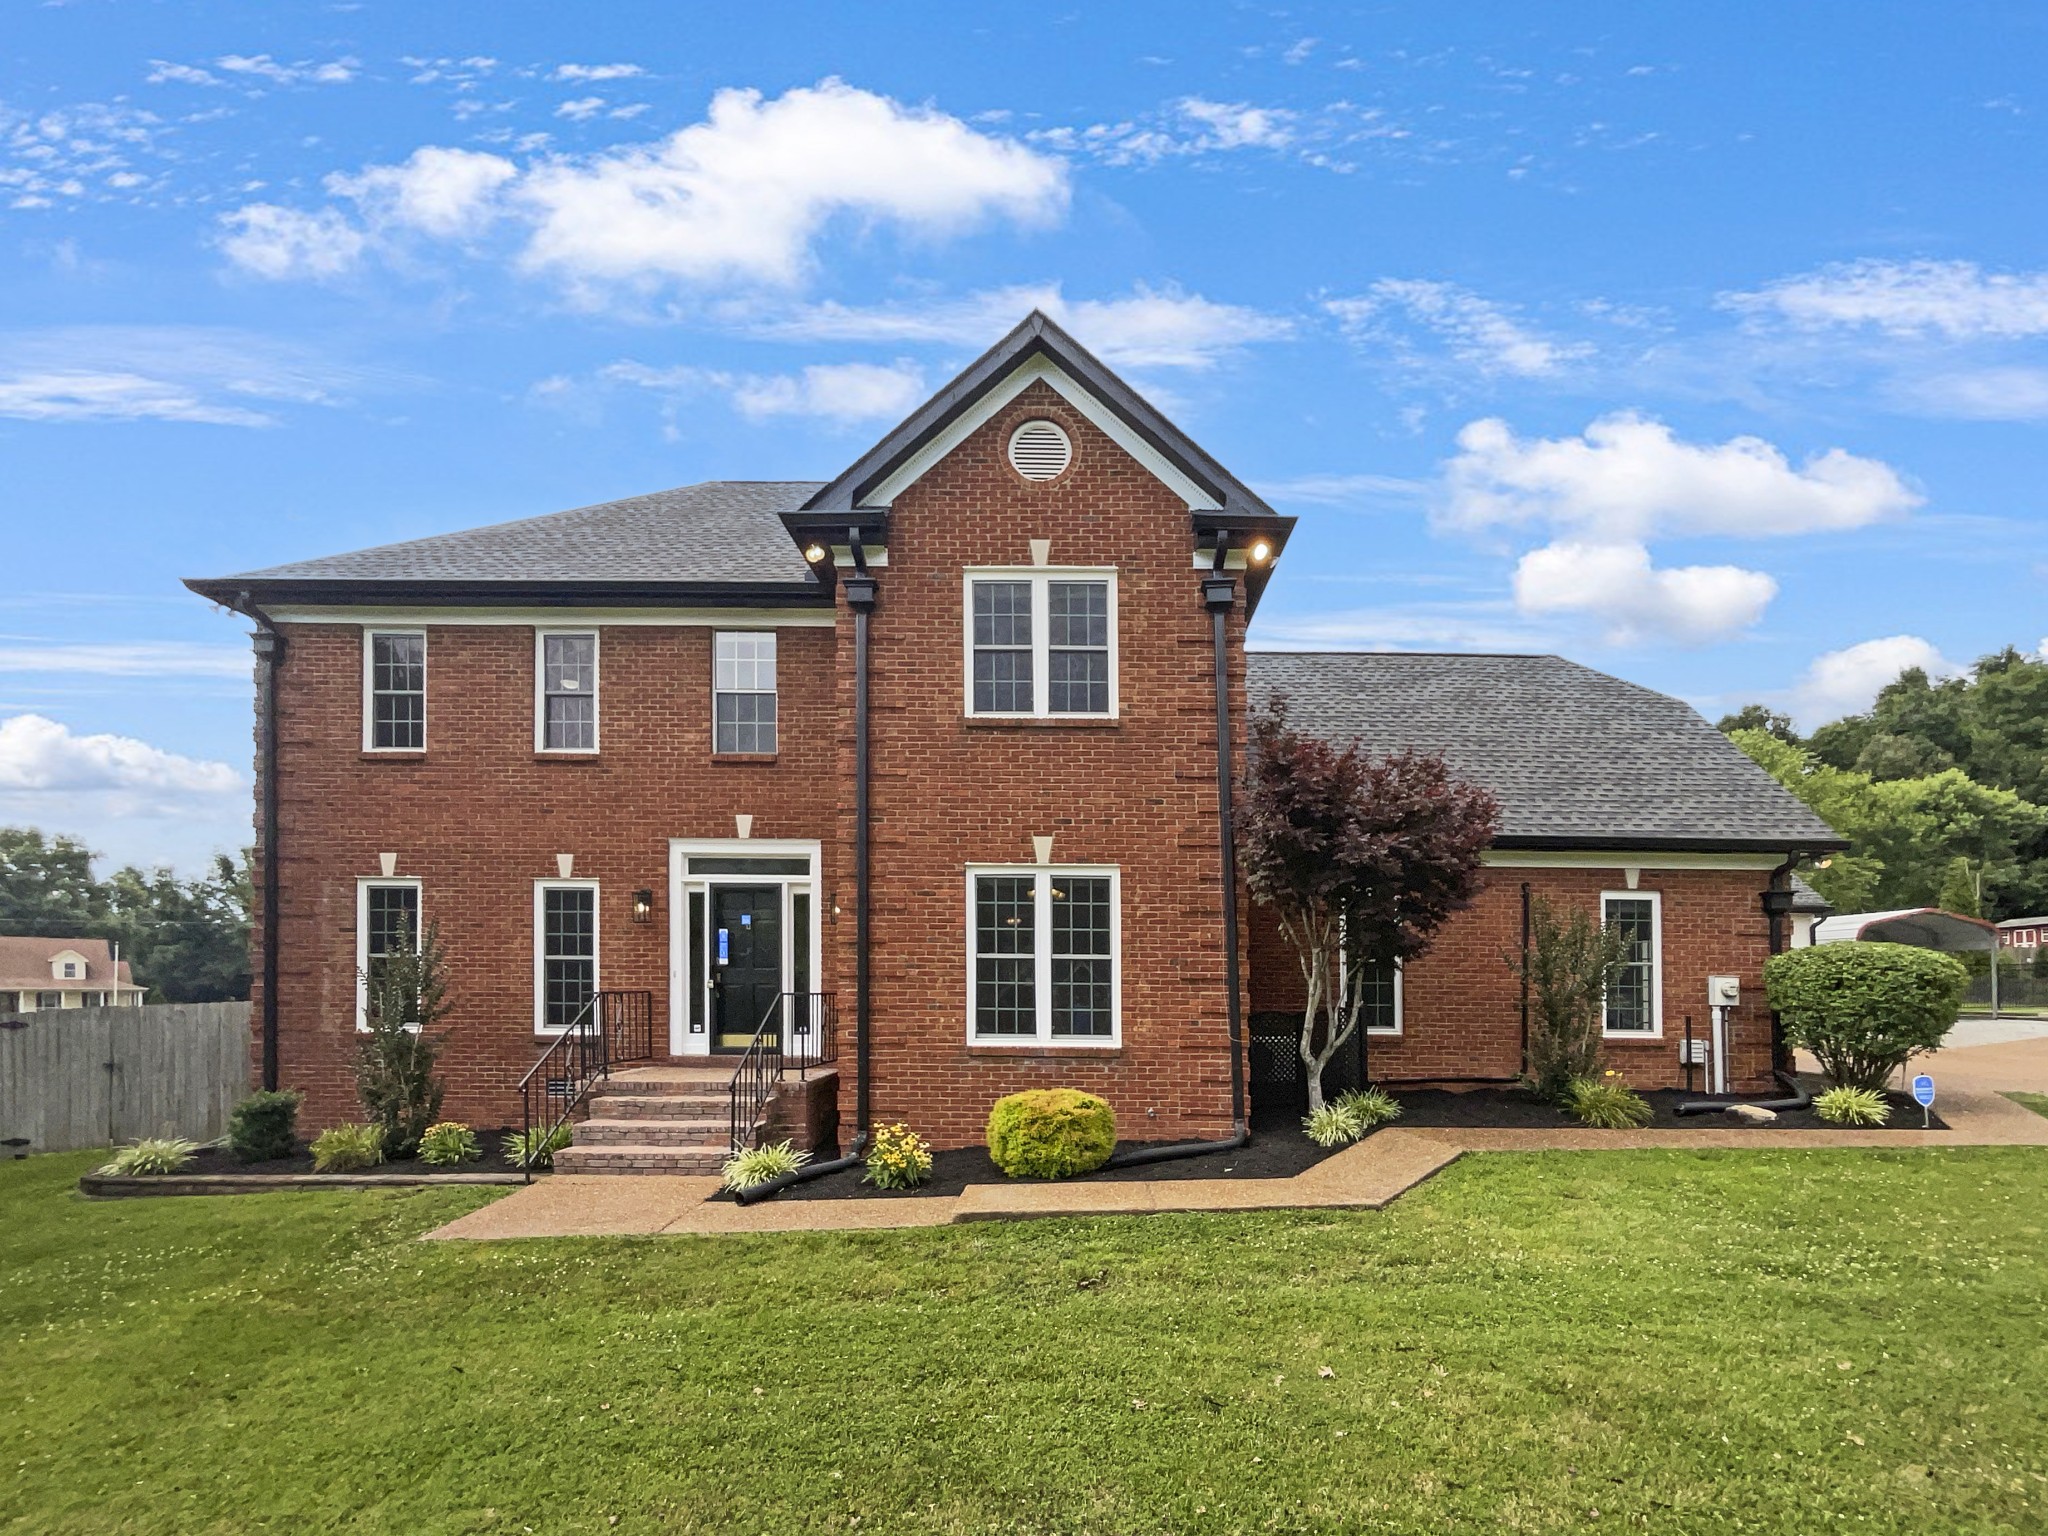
(254, 625), (852, 1128)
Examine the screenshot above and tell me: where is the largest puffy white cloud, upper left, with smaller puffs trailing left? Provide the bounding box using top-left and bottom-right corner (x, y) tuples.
(223, 80), (1069, 299)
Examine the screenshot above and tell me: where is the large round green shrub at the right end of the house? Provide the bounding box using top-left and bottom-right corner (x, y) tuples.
(1763, 942), (1970, 1090)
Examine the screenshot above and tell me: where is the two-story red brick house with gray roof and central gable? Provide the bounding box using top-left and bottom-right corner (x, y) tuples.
(188, 313), (1839, 1167)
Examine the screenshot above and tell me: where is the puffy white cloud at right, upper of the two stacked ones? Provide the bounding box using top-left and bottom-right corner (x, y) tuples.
(1440, 412), (1921, 543)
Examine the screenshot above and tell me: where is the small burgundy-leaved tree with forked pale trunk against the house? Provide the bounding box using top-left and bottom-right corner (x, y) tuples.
(1237, 696), (1501, 1114)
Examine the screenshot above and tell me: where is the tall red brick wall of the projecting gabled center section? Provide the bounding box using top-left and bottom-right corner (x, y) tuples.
(838, 383), (1243, 1147)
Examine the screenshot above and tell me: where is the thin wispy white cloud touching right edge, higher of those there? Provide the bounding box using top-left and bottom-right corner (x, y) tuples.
(1722, 260), (2048, 340)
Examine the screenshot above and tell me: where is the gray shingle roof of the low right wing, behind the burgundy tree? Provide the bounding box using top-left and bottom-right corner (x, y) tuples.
(1247, 651), (1843, 850)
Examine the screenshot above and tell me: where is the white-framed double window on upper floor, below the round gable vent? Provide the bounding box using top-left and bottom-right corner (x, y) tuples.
(961, 565), (1118, 719)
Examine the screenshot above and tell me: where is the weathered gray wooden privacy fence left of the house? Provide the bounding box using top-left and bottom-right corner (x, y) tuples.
(0, 1004), (250, 1151)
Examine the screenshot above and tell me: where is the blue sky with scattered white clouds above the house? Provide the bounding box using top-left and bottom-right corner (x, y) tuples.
(0, 0), (2048, 868)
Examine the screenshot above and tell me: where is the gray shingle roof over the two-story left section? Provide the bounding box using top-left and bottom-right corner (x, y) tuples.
(209, 479), (819, 586)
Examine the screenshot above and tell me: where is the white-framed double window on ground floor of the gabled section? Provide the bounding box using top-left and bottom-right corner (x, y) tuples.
(967, 864), (1124, 1047)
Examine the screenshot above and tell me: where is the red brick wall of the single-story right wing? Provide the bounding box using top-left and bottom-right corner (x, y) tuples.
(1251, 868), (1772, 1092)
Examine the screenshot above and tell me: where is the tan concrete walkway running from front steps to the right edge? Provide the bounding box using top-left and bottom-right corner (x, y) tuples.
(428, 1081), (2048, 1239)
